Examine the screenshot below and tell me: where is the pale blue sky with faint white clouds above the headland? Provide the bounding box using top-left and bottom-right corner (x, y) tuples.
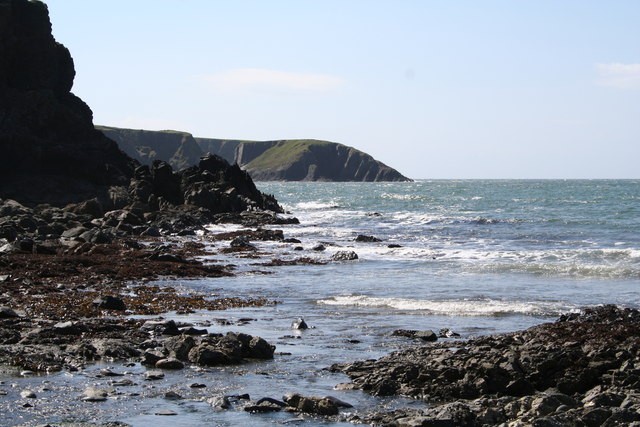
(45, 0), (640, 179)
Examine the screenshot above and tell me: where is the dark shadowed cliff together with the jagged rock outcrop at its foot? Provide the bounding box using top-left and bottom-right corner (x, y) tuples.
(0, 0), (282, 224)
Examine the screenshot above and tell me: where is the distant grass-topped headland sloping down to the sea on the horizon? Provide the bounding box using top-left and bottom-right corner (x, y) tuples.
(98, 127), (410, 181)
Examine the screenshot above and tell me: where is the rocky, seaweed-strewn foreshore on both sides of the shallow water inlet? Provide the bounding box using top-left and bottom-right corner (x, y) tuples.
(0, 207), (640, 426)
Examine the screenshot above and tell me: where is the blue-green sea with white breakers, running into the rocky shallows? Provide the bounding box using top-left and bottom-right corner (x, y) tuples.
(2, 180), (640, 427)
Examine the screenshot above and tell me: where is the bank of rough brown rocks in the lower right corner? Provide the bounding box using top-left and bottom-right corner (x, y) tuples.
(332, 306), (640, 426)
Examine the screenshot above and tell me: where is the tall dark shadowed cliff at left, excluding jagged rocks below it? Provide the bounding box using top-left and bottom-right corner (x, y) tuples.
(0, 0), (135, 206)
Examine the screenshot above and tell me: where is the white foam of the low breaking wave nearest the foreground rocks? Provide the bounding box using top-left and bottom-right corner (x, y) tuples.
(317, 295), (578, 316)
